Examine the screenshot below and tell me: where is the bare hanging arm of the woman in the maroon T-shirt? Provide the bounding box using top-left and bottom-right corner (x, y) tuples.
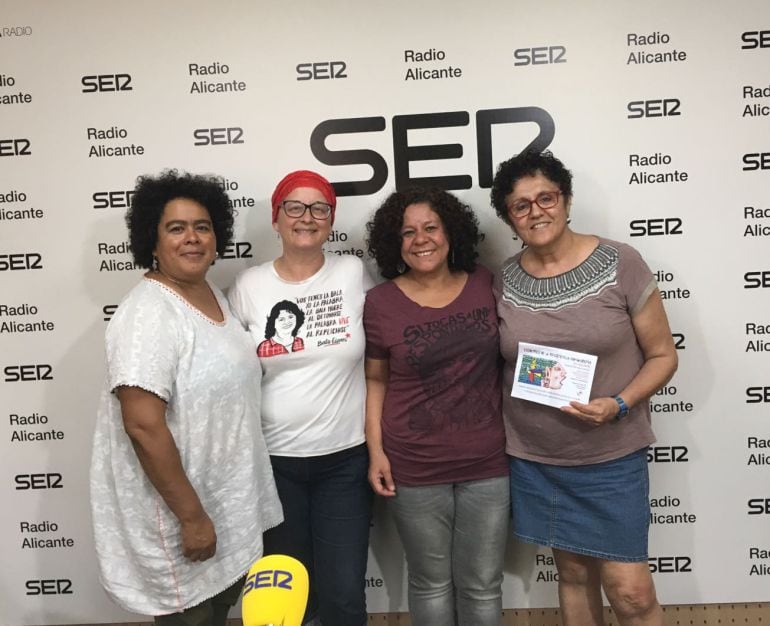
(364, 358), (396, 497)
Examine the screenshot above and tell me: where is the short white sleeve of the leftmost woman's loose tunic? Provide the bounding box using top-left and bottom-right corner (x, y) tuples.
(106, 292), (181, 402)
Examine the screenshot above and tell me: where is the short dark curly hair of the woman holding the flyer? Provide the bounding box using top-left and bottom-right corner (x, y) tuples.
(489, 150), (572, 225)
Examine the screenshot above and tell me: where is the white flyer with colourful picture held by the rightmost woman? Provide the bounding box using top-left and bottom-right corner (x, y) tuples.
(511, 342), (597, 409)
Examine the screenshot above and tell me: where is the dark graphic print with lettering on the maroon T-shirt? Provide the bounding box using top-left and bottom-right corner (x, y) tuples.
(404, 307), (498, 431)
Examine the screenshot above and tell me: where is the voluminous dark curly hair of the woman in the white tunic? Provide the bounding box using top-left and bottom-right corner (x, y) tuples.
(126, 170), (233, 269)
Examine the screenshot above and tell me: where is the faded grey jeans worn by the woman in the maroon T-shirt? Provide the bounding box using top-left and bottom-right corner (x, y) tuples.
(388, 476), (510, 626)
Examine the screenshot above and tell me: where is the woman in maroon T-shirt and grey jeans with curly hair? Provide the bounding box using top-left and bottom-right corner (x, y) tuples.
(364, 188), (509, 626)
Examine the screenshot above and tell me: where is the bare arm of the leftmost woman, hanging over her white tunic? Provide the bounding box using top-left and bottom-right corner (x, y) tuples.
(115, 387), (217, 561)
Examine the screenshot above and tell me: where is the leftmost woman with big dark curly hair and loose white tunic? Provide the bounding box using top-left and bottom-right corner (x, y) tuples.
(91, 170), (282, 625)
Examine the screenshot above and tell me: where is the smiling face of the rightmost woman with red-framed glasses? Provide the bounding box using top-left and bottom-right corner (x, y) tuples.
(505, 172), (572, 250)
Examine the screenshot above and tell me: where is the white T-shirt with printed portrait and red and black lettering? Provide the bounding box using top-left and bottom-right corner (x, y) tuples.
(228, 254), (372, 457)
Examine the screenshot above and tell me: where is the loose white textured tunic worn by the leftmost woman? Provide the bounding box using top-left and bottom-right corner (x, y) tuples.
(91, 279), (282, 615)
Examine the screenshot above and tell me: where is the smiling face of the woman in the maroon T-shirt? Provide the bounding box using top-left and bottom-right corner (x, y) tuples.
(401, 202), (449, 273)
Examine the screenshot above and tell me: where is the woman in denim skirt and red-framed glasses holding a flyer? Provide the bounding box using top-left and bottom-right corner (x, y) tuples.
(491, 151), (677, 626)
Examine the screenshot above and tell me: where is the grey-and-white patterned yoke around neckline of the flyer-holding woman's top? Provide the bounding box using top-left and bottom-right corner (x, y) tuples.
(502, 243), (619, 311)
